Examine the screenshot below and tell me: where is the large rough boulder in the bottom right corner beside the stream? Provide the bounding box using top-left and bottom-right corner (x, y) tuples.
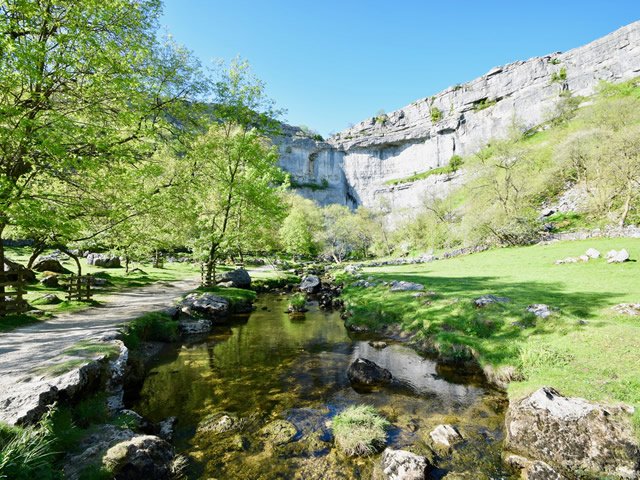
(505, 387), (640, 479)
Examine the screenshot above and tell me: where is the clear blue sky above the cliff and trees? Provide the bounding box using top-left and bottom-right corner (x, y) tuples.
(162, 0), (640, 135)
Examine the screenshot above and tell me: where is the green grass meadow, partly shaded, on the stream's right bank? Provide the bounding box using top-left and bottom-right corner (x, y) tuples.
(343, 238), (640, 411)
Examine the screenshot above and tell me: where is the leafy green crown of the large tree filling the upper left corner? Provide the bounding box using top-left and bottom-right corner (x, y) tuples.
(0, 0), (206, 304)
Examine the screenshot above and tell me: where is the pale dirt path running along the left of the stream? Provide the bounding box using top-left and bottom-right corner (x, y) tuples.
(0, 279), (198, 382)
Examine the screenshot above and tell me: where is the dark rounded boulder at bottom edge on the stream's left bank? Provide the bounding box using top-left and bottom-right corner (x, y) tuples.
(102, 435), (174, 480)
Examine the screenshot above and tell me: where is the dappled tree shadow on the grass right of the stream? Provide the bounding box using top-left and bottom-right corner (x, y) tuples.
(343, 272), (620, 364)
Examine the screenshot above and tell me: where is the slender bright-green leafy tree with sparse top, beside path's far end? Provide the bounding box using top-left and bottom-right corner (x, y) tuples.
(184, 59), (286, 285)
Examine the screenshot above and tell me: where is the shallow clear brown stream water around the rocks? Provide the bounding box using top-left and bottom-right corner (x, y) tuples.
(132, 295), (511, 480)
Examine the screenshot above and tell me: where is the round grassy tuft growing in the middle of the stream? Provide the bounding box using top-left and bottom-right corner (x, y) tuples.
(333, 405), (389, 457)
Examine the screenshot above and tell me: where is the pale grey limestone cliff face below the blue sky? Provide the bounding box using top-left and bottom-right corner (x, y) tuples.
(278, 22), (640, 212)
